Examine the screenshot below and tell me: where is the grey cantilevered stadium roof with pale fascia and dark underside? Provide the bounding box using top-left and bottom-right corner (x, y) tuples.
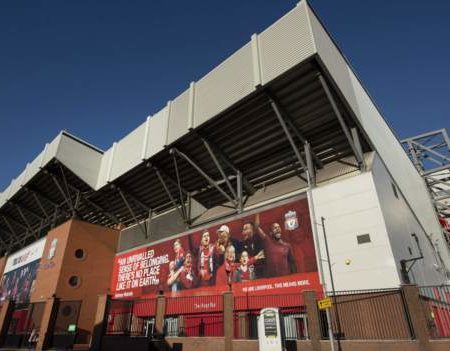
(0, 1), (438, 264)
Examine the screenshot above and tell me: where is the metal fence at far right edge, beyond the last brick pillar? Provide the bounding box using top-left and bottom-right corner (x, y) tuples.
(419, 285), (450, 339)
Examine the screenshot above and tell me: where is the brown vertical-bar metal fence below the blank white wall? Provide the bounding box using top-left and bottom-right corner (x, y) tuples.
(320, 289), (413, 340)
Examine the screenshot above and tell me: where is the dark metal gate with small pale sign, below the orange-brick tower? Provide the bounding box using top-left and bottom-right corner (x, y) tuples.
(49, 301), (82, 349)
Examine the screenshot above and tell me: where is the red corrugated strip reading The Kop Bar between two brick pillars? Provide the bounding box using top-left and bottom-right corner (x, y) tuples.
(166, 295), (223, 315)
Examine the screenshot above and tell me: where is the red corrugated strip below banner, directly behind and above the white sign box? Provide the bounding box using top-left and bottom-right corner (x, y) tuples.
(234, 294), (304, 311)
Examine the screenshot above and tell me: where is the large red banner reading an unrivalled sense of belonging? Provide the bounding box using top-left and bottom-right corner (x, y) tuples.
(111, 199), (320, 298)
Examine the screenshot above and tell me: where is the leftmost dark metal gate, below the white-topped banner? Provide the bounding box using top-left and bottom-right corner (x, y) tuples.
(3, 302), (45, 348)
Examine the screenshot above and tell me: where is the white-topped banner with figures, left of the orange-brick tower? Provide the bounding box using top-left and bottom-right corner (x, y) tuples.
(0, 238), (45, 303)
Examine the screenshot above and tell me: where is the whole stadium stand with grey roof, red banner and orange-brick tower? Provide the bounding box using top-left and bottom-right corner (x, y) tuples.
(0, 1), (450, 348)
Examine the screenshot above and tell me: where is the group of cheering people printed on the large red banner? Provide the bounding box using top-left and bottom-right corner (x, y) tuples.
(167, 215), (297, 291)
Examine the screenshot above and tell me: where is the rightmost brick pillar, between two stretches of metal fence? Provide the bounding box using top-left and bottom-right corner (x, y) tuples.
(401, 284), (430, 351)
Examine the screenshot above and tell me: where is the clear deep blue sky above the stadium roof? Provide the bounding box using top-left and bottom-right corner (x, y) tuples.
(0, 0), (450, 190)
